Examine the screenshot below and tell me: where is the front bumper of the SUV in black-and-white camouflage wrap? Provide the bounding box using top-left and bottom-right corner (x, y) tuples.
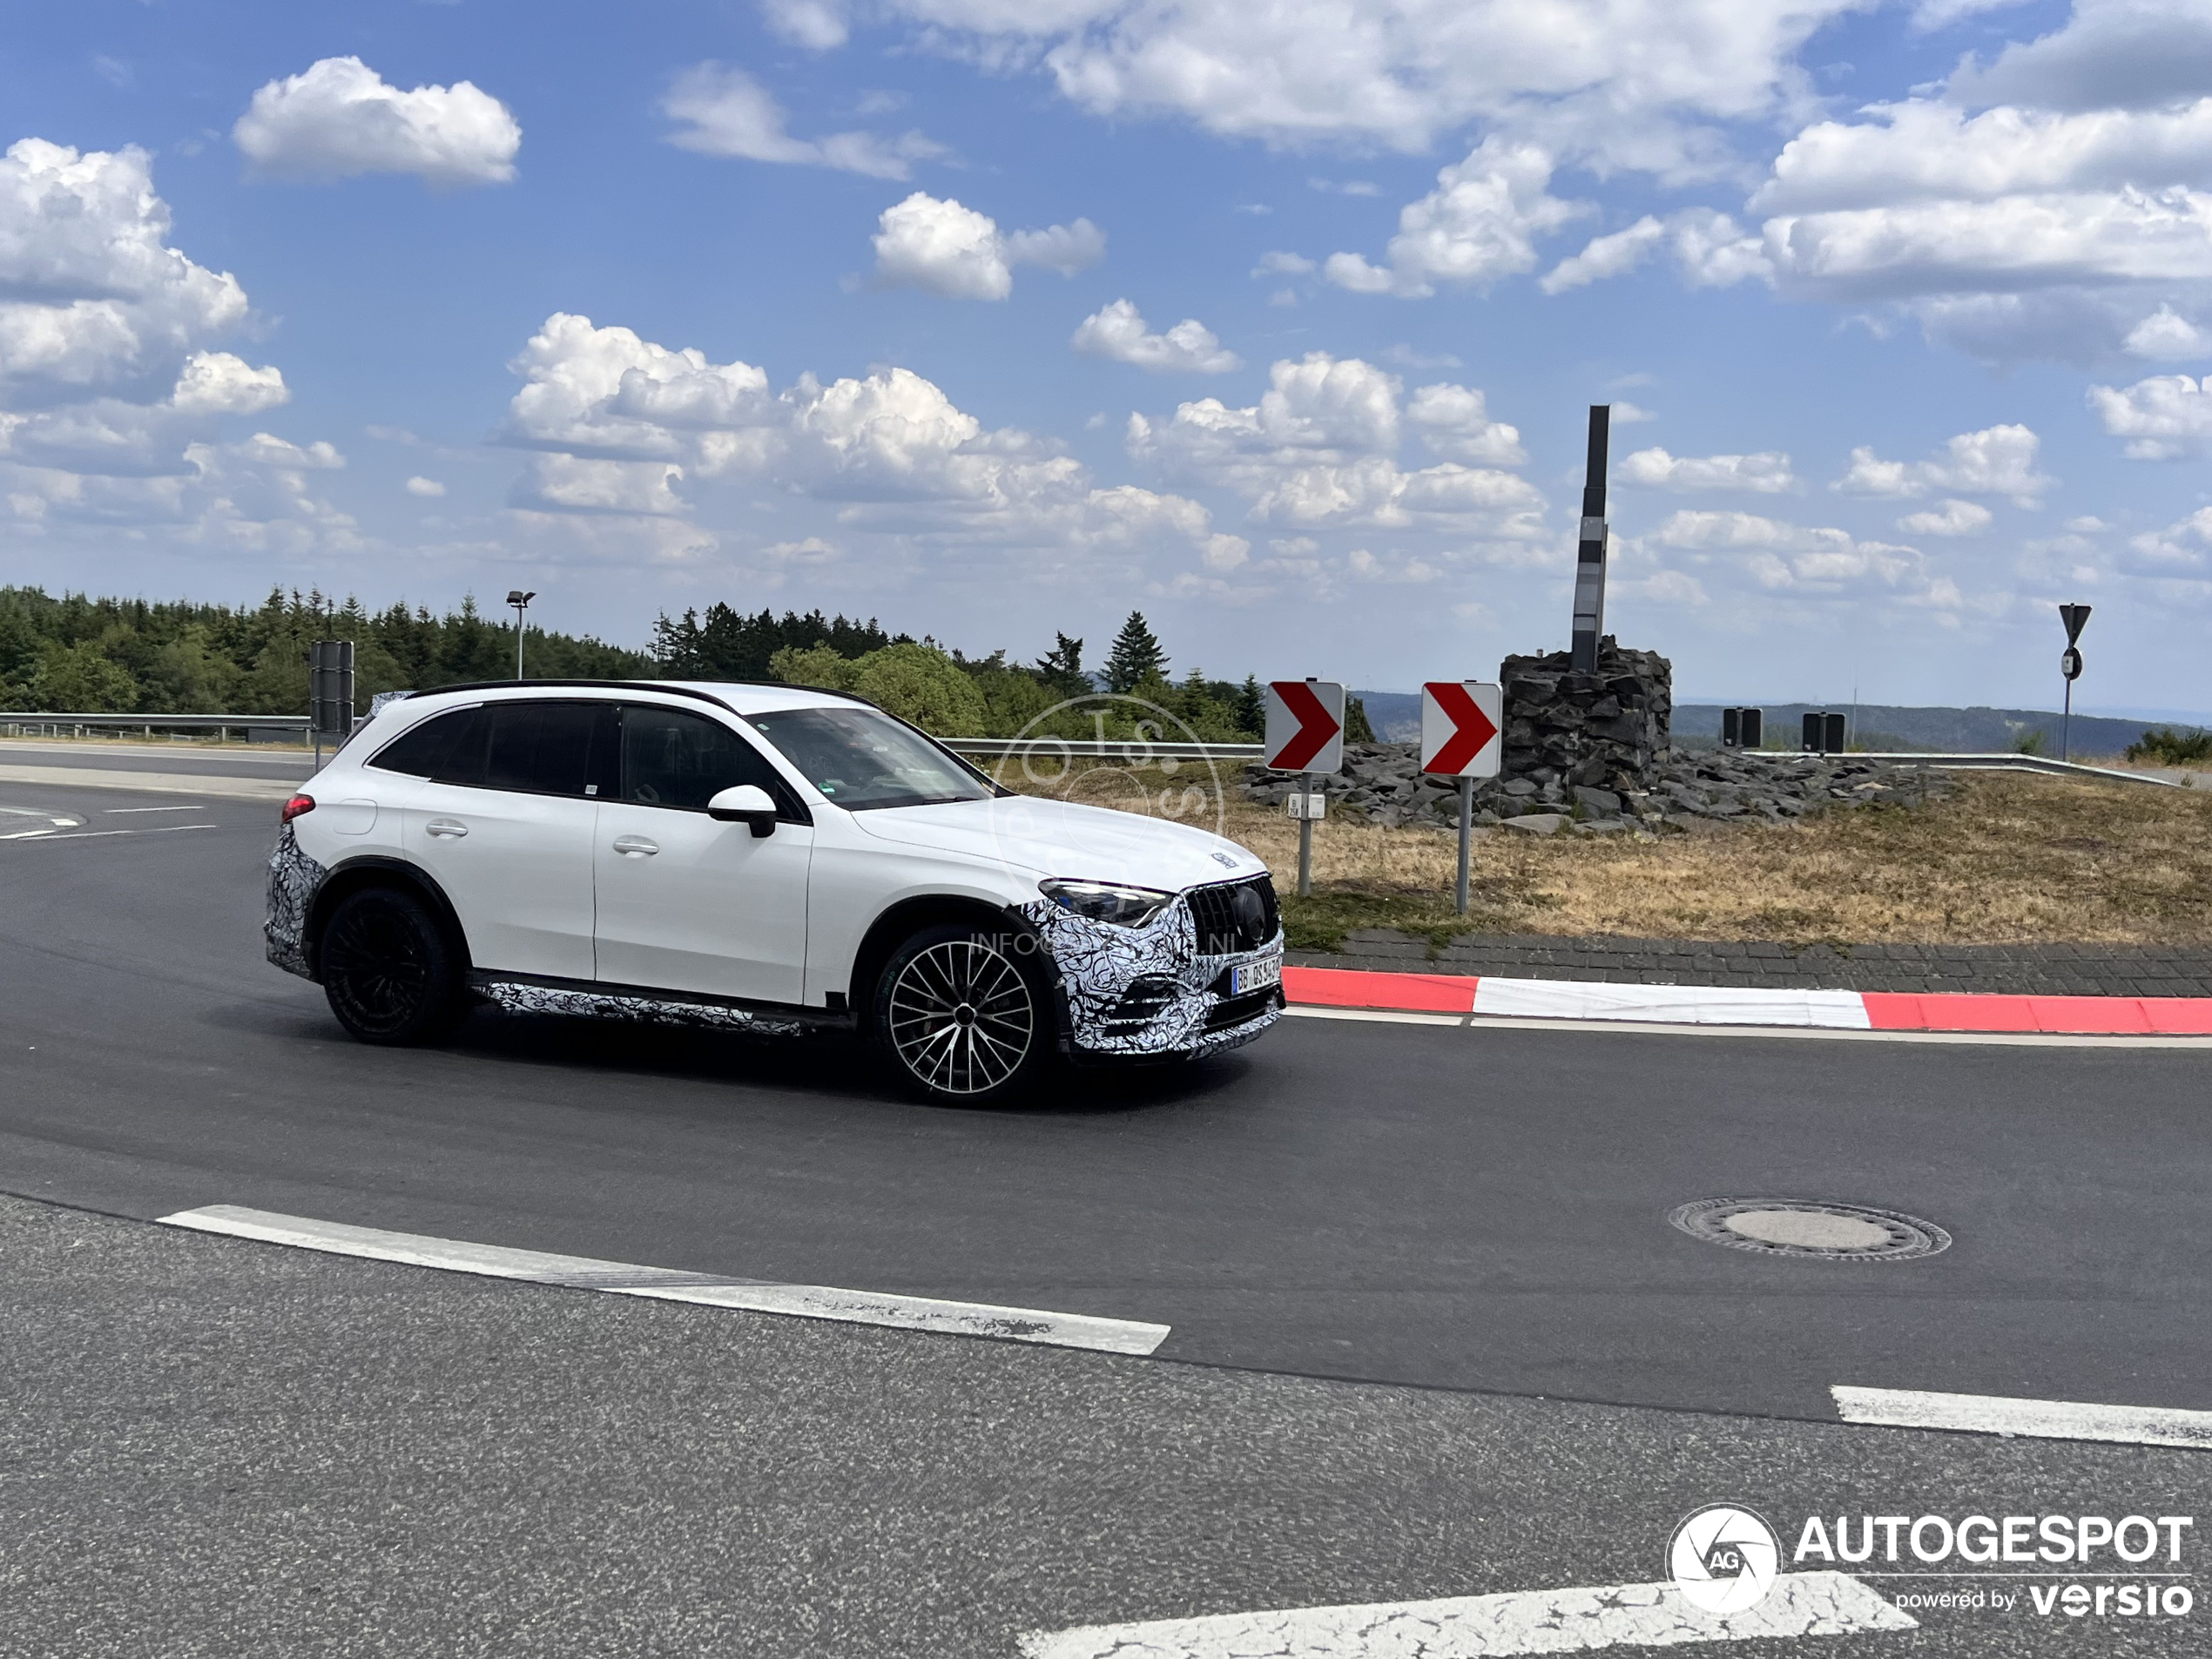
(1020, 896), (1283, 1057)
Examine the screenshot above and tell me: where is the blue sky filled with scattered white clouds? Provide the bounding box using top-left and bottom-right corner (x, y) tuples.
(0, 0), (2212, 710)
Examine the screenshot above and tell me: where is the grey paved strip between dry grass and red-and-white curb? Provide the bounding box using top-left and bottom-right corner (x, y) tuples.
(1287, 929), (2212, 998)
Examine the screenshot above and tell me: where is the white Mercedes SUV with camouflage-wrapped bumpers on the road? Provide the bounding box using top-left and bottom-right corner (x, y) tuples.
(266, 679), (1283, 1102)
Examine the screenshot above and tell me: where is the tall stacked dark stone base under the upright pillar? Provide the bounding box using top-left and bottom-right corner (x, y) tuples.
(1498, 635), (1675, 794)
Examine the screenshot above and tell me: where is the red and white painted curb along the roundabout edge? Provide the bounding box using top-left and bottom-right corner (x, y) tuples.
(1283, 967), (2212, 1037)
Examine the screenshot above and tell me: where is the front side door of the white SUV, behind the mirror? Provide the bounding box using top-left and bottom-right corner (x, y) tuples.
(593, 704), (814, 1002)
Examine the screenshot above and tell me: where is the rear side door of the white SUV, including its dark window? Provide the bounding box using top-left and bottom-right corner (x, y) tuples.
(394, 699), (615, 980)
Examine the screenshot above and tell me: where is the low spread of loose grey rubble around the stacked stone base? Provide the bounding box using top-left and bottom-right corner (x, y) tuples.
(1243, 743), (1951, 836)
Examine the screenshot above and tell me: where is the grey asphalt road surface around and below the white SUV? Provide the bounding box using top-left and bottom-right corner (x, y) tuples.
(0, 783), (2212, 1656)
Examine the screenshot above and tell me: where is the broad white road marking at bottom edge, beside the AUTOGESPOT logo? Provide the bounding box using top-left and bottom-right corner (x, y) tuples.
(1022, 1573), (1920, 1659)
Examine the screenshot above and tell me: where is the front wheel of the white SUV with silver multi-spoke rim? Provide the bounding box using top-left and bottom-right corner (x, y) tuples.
(869, 925), (1057, 1106)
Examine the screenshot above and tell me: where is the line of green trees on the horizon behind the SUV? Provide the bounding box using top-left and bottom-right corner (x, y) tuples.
(0, 589), (1372, 743)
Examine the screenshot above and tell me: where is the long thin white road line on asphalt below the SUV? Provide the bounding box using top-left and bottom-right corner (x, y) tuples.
(161, 1204), (1168, 1353)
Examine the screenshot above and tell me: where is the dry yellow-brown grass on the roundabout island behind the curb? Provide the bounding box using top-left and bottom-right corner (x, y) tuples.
(1008, 772), (2212, 947)
